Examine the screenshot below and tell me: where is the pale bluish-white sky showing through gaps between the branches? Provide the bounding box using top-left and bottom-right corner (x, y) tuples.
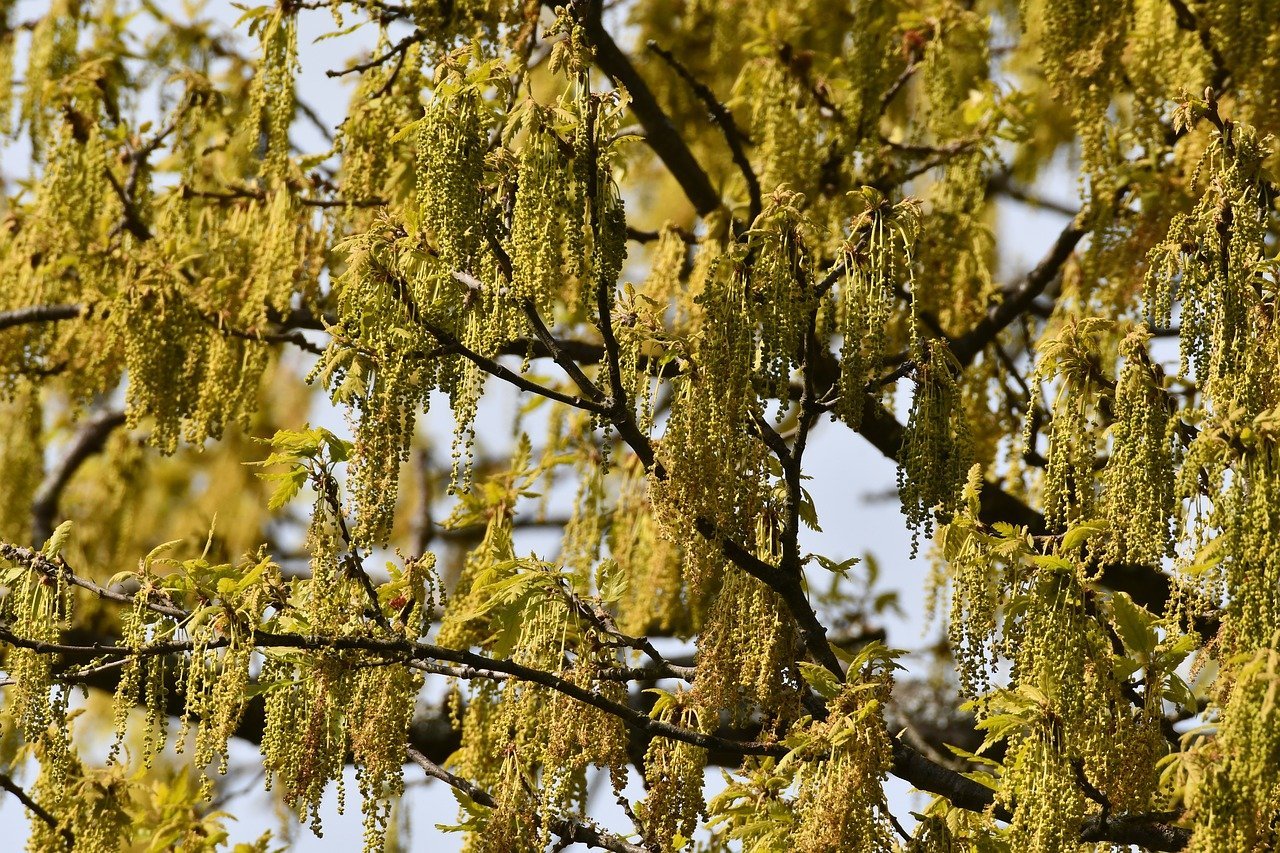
(0, 0), (1076, 853)
